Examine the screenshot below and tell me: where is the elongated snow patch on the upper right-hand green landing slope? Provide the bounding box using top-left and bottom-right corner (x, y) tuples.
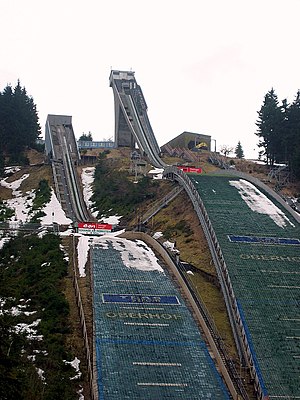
(229, 179), (295, 228)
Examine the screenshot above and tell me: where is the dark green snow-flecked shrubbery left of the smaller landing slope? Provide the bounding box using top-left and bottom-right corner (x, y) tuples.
(0, 235), (81, 400)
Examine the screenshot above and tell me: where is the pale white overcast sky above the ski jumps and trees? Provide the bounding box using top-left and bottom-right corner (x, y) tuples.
(0, 0), (300, 158)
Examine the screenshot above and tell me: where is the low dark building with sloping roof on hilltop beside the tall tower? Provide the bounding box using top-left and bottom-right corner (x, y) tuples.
(161, 131), (211, 152)
